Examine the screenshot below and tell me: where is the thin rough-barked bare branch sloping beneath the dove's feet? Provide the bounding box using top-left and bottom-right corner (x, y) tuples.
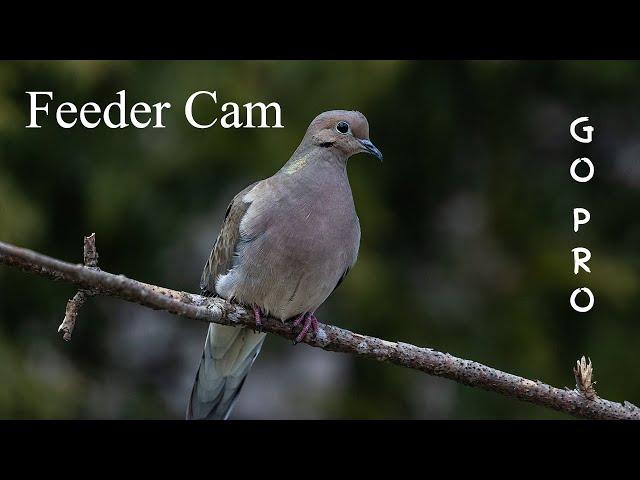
(0, 237), (640, 420)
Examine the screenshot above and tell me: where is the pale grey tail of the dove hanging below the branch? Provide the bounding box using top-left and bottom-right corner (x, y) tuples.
(187, 323), (266, 420)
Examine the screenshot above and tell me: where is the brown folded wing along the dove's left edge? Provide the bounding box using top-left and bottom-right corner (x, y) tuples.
(200, 182), (259, 295)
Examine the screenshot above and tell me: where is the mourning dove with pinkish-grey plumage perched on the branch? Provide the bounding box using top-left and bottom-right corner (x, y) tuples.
(186, 110), (383, 420)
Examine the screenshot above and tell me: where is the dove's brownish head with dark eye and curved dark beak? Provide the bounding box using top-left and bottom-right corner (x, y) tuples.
(305, 110), (382, 161)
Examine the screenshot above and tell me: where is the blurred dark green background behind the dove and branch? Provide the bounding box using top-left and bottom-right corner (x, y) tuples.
(0, 61), (640, 419)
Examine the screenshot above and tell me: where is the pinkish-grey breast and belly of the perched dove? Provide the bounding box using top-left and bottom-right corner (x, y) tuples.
(229, 172), (360, 319)
